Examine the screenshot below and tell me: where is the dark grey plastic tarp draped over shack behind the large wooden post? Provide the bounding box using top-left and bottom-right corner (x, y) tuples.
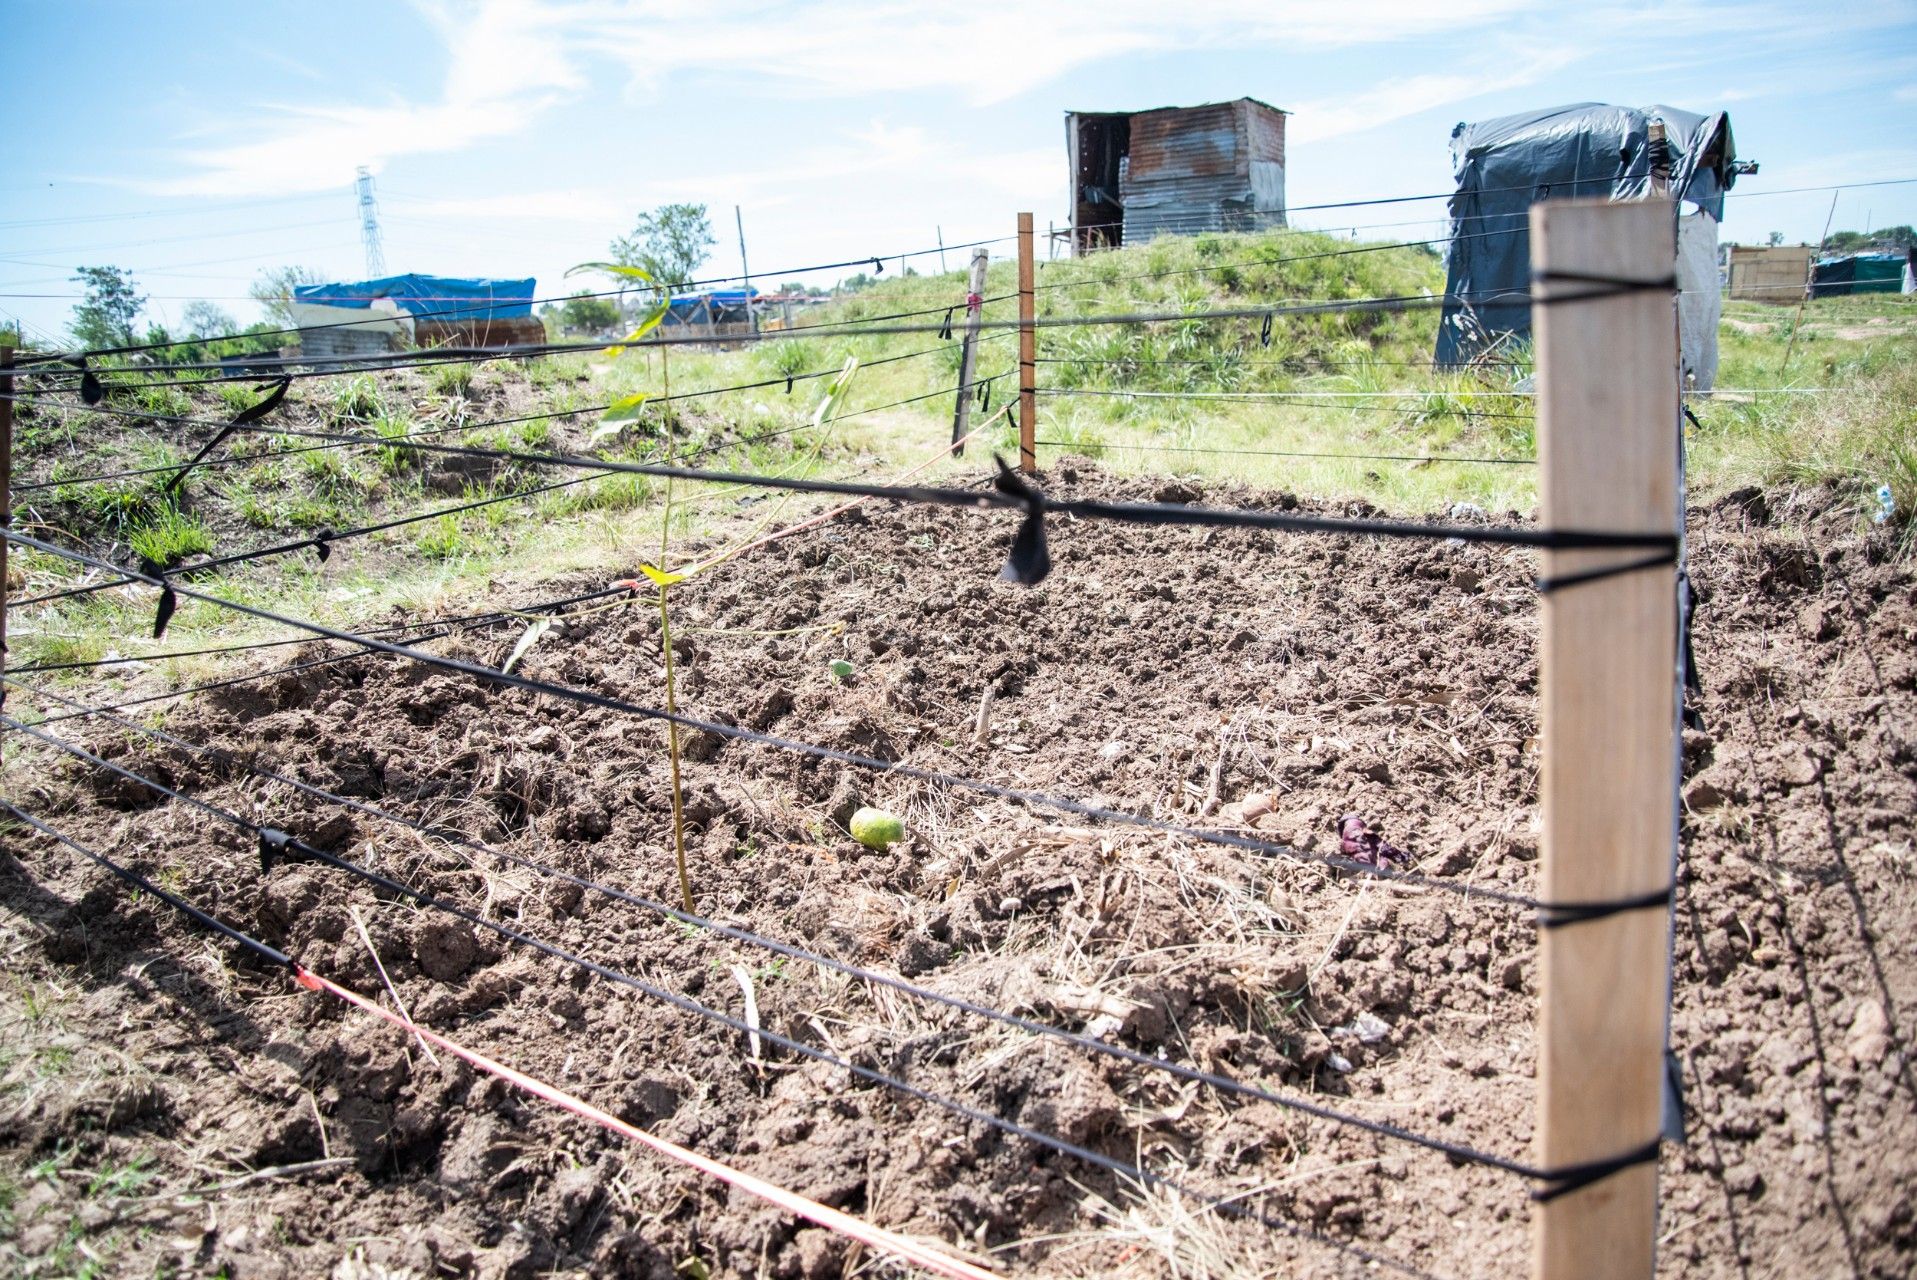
(1438, 102), (1737, 364)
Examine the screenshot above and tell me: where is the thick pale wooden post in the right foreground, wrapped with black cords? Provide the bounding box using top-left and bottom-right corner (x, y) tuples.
(1532, 199), (1683, 1280)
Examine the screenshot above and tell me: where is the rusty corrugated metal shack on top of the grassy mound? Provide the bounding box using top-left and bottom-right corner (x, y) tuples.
(1066, 98), (1286, 253)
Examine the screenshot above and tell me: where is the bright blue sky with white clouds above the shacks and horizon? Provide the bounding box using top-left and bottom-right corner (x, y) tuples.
(0, 0), (1917, 337)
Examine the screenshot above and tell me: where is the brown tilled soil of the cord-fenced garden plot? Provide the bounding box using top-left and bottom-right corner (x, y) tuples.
(0, 464), (1917, 1278)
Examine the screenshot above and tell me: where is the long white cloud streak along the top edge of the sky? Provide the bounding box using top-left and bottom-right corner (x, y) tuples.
(142, 0), (1526, 195)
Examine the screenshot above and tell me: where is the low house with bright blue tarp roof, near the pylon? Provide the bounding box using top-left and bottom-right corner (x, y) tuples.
(291, 274), (546, 360)
